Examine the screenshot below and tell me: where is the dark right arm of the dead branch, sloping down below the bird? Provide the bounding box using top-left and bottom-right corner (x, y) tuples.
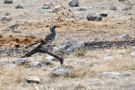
(39, 48), (64, 65)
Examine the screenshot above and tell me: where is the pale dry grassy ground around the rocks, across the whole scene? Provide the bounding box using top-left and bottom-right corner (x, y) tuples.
(0, 0), (135, 90)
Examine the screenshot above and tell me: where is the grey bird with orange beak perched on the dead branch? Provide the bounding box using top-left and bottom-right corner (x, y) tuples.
(25, 24), (60, 48)
